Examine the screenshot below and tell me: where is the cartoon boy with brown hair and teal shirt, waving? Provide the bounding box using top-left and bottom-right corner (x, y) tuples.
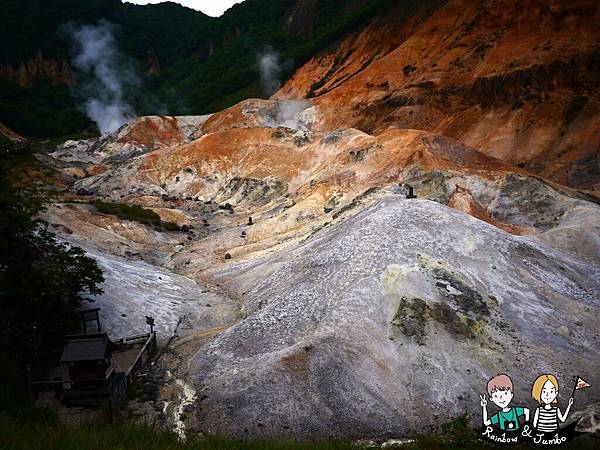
(479, 373), (529, 431)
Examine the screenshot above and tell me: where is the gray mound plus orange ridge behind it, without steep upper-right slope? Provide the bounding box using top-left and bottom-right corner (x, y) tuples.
(47, 96), (600, 438)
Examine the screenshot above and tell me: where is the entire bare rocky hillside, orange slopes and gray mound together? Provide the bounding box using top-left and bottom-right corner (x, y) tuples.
(22, 0), (600, 439)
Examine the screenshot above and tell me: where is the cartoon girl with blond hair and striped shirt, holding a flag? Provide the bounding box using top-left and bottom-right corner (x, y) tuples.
(531, 374), (573, 433)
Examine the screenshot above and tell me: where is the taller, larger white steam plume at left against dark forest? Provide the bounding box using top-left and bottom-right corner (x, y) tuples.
(66, 21), (139, 134)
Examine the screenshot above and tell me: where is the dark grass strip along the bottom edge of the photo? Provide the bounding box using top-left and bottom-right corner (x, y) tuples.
(0, 402), (598, 450)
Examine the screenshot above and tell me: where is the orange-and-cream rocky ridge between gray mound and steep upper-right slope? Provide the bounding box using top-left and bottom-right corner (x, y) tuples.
(57, 90), (592, 270)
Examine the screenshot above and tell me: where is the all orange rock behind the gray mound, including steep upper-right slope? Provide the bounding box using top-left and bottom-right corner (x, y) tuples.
(48, 0), (600, 270)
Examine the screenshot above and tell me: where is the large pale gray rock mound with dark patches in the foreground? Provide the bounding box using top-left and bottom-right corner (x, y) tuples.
(185, 196), (600, 438)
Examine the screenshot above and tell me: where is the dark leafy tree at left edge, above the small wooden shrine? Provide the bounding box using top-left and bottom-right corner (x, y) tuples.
(0, 156), (104, 385)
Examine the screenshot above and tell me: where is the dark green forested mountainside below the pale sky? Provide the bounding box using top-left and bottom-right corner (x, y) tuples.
(0, 0), (393, 137)
